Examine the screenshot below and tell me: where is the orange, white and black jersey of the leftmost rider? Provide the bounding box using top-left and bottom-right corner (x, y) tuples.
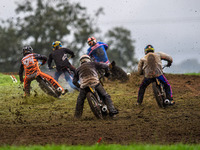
(19, 53), (47, 81)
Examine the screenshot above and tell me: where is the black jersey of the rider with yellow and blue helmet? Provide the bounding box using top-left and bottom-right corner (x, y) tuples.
(48, 48), (74, 70)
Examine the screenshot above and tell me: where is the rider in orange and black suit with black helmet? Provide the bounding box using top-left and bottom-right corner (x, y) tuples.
(19, 46), (64, 96)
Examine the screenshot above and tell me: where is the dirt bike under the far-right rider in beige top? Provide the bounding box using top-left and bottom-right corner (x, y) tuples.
(152, 66), (168, 108)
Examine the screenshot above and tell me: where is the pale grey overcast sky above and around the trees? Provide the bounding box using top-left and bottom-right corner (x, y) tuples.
(0, 0), (200, 64)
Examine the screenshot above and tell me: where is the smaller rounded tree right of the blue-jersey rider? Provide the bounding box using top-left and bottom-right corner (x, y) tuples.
(105, 27), (137, 69)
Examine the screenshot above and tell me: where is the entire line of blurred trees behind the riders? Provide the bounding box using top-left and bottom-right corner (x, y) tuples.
(0, 0), (137, 72)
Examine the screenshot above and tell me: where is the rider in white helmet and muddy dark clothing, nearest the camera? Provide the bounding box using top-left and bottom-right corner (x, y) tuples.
(73, 55), (118, 118)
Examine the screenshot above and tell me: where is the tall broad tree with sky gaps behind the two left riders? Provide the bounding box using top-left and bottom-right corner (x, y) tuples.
(16, 0), (99, 62)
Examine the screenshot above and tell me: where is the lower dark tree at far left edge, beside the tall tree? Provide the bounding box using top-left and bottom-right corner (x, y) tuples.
(0, 20), (22, 72)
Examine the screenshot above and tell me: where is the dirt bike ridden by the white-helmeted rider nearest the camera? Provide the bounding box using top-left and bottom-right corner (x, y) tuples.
(86, 86), (108, 119)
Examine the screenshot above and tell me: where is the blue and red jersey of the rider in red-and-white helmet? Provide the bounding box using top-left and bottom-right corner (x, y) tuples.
(87, 42), (110, 64)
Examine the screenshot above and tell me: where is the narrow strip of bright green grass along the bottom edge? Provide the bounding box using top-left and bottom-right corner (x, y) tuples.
(0, 144), (200, 150)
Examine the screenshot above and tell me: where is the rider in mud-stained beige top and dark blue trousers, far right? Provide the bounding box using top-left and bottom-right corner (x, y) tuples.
(137, 45), (175, 105)
